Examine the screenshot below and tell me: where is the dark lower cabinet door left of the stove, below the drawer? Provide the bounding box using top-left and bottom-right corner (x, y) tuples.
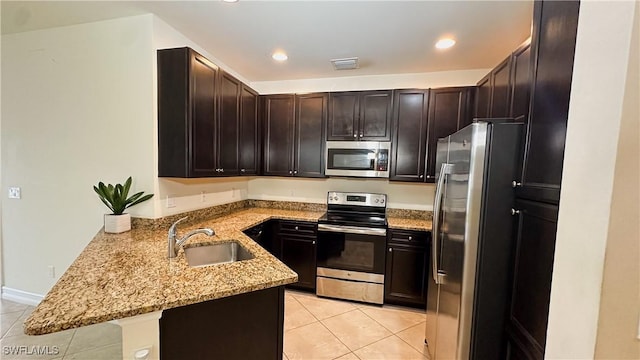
(281, 236), (316, 290)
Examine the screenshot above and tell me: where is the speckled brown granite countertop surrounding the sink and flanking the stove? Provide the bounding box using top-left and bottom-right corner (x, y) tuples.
(24, 208), (431, 335)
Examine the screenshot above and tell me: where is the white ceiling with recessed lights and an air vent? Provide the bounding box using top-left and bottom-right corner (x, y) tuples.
(1, 0), (533, 81)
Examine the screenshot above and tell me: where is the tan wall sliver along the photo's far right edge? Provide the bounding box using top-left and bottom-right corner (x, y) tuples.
(595, 5), (640, 359)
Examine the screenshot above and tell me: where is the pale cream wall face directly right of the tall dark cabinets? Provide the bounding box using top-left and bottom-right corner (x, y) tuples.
(545, 0), (639, 359)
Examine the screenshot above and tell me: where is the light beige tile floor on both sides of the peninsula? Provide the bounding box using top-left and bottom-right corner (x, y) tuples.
(0, 290), (428, 360)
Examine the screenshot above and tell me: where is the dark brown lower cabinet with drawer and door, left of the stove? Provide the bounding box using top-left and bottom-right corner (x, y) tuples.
(278, 221), (317, 291)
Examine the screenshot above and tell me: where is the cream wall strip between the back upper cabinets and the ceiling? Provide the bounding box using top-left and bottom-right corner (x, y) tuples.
(251, 69), (488, 95)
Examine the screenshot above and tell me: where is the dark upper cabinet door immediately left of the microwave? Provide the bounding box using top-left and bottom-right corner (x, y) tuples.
(293, 93), (329, 177)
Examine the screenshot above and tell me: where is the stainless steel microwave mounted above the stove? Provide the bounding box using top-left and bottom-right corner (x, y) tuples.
(325, 141), (391, 178)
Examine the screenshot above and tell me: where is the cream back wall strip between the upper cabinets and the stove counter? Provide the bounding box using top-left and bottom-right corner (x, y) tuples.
(248, 176), (435, 210)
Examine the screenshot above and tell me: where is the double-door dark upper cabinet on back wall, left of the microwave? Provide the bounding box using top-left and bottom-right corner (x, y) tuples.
(262, 93), (329, 177)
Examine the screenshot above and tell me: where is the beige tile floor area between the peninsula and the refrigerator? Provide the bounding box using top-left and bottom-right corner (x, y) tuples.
(284, 290), (428, 360)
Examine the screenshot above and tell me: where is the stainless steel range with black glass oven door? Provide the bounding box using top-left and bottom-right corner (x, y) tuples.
(316, 191), (387, 304)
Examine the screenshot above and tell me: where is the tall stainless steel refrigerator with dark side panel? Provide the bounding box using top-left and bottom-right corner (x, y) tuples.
(425, 119), (523, 360)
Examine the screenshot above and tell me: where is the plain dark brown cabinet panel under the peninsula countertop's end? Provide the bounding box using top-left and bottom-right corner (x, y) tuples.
(160, 286), (284, 360)
